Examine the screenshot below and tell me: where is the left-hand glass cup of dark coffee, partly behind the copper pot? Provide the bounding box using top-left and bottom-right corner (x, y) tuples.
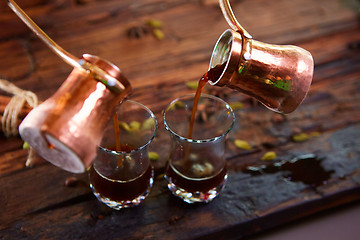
(89, 100), (157, 210)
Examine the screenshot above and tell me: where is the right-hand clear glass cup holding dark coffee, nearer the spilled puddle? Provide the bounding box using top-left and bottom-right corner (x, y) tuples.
(163, 94), (235, 203)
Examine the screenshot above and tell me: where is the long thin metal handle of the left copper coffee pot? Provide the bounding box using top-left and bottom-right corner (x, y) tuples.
(7, 0), (125, 93)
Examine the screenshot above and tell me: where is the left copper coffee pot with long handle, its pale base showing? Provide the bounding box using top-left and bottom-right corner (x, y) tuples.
(8, 0), (131, 173)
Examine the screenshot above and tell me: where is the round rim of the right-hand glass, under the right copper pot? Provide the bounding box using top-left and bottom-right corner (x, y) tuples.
(163, 93), (235, 143)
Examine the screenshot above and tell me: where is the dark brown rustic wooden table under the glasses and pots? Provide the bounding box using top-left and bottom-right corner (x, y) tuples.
(0, 0), (360, 239)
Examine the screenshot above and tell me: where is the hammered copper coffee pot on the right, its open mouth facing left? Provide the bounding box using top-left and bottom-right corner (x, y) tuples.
(209, 0), (314, 113)
